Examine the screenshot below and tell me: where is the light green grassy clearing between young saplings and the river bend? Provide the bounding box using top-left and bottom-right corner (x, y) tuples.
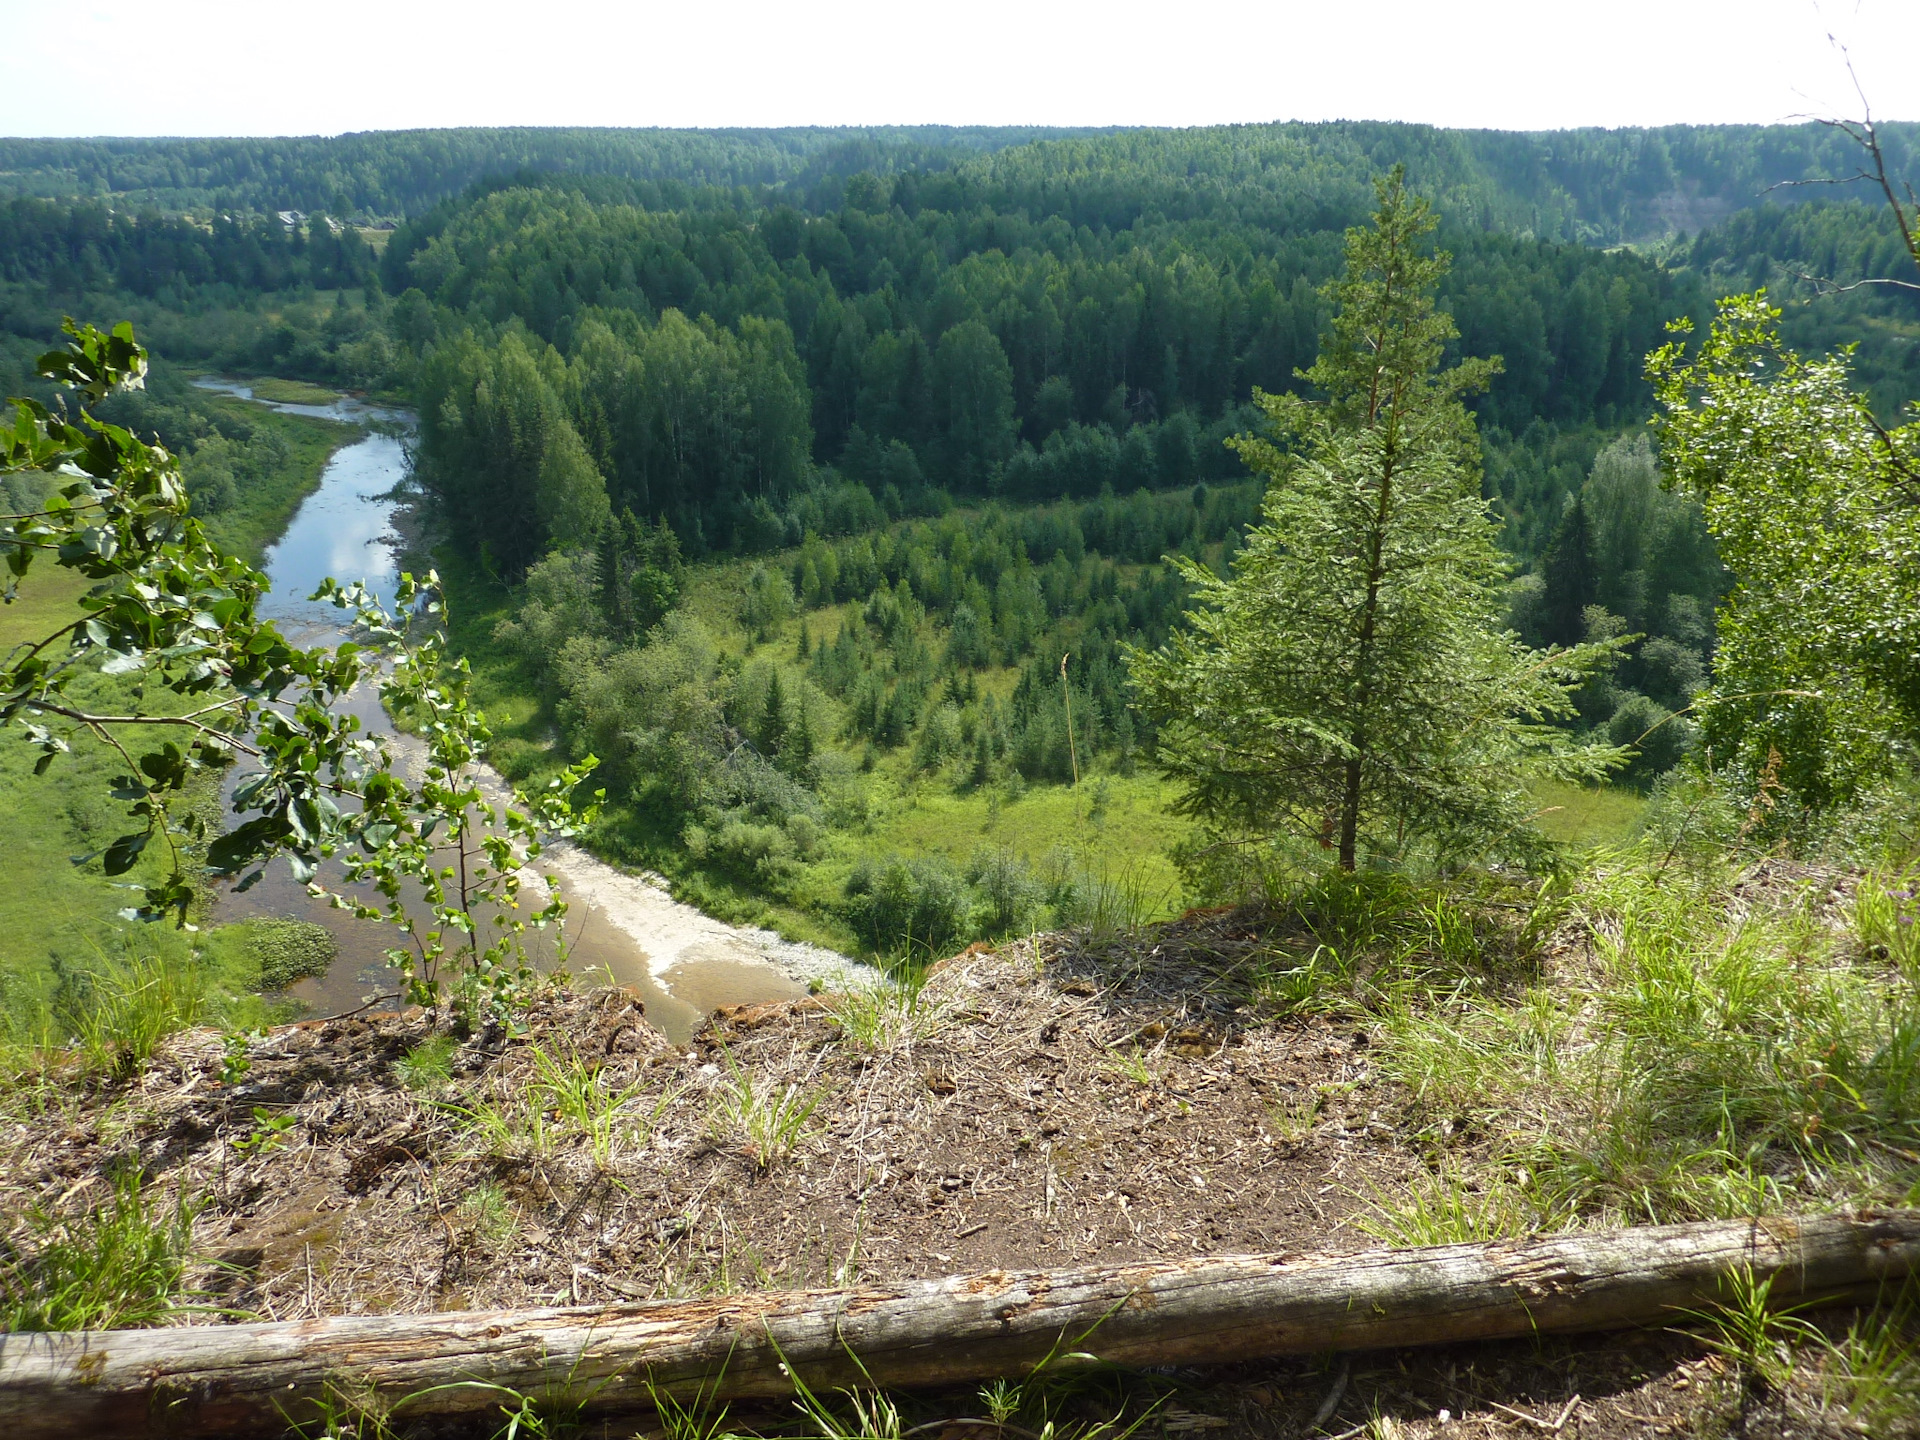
(438, 537), (1644, 956)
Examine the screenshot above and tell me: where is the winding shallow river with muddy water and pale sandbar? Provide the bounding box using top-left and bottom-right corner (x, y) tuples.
(198, 380), (874, 1041)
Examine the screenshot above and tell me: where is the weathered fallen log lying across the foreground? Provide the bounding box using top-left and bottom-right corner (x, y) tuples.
(0, 1210), (1920, 1440)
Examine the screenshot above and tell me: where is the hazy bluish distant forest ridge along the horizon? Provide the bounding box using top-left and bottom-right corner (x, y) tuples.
(0, 121), (1912, 242)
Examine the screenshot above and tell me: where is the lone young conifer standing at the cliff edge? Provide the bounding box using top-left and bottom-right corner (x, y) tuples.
(1131, 169), (1619, 870)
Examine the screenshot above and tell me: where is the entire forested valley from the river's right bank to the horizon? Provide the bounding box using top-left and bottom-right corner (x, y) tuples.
(0, 125), (1920, 948)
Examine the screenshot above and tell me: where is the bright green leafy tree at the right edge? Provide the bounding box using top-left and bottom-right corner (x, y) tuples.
(1647, 296), (1920, 824)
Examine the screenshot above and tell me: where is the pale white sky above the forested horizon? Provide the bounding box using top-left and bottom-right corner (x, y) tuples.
(0, 0), (1920, 136)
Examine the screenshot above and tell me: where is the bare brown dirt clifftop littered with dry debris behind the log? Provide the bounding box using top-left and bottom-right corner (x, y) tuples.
(0, 912), (1889, 1440)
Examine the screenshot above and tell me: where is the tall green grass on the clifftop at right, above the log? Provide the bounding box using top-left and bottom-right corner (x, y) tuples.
(1375, 847), (1920, 1238)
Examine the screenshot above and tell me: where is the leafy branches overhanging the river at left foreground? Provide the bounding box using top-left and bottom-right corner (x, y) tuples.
(0, 321), (591, 1021)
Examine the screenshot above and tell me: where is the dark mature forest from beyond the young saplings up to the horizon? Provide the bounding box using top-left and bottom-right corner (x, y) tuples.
(0, 123), (1914, 559)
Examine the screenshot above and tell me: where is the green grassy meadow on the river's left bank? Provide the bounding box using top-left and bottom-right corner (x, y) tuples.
(0, 369), (355, 1064)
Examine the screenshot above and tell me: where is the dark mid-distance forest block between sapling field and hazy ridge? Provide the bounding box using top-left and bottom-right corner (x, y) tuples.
(382, 175), (1701, 563)
